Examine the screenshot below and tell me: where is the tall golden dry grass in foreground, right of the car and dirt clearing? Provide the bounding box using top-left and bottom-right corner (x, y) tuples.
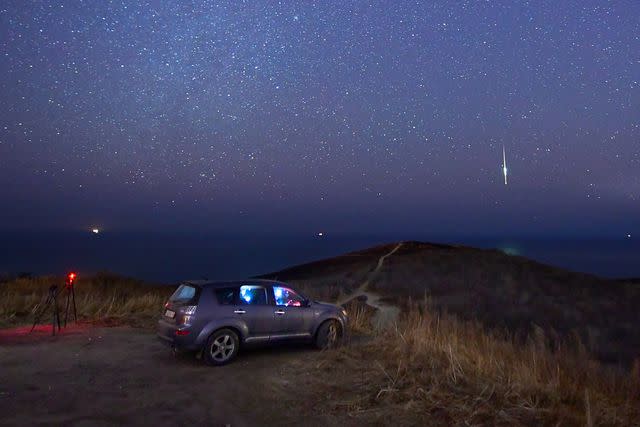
(313, 305), (640, 426)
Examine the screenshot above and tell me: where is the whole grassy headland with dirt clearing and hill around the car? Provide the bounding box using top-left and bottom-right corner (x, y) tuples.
(0, 246), (640, 427)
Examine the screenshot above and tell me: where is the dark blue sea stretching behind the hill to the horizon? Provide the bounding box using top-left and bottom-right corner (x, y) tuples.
(0, 232), (640, 284)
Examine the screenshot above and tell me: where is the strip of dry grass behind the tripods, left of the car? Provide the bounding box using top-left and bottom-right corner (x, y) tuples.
(0, 273), (174, 327)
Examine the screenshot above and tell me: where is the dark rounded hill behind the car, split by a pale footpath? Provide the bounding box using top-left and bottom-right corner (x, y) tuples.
(263, 242), (640, 363)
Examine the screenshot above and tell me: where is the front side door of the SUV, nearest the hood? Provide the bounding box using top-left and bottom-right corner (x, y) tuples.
(272, 285), (310, 339)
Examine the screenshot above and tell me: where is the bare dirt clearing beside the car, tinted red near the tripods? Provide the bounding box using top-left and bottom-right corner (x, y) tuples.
(0, 326), (351, 426)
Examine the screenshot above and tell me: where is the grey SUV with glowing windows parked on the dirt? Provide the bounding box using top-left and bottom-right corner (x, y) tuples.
(158, 280), (347, 365)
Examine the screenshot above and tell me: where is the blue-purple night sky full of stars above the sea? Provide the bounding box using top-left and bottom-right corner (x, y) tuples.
(0, 0), (640, 238)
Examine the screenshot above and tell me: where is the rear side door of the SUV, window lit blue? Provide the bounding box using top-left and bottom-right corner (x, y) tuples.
(234, 284), (277, 341)
